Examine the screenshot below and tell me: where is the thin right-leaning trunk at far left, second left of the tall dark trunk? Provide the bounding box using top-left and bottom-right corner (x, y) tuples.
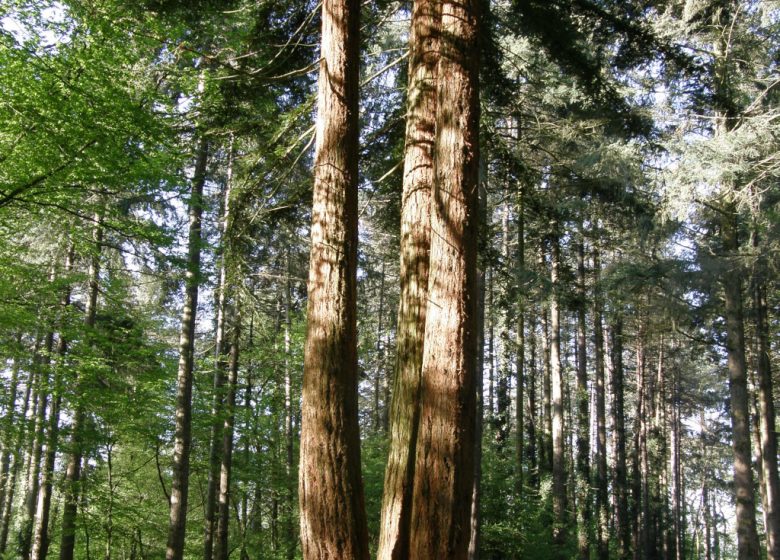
(30, 246), (73, 560)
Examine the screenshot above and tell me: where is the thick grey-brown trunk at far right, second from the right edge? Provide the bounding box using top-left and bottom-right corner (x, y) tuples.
(721, 210), (760, 560)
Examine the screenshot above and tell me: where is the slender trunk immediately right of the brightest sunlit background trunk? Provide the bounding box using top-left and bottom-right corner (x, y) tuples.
(576, 239), (601, 560)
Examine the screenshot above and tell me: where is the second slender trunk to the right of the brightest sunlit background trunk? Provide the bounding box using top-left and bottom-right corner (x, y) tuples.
(593, 248), (609, 560)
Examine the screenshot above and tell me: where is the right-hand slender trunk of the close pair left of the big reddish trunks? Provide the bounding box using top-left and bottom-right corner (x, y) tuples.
(214, 312), (241, 560)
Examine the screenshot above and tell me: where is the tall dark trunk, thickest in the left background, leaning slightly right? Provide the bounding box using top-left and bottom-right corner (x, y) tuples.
(165, 139), (209, 560)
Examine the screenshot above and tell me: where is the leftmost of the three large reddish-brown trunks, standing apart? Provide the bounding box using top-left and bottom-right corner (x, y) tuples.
(299, 0), (368, 560)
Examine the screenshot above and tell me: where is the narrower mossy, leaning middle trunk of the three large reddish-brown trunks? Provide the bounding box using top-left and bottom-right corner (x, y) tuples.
(377, 0), (441, 560)
